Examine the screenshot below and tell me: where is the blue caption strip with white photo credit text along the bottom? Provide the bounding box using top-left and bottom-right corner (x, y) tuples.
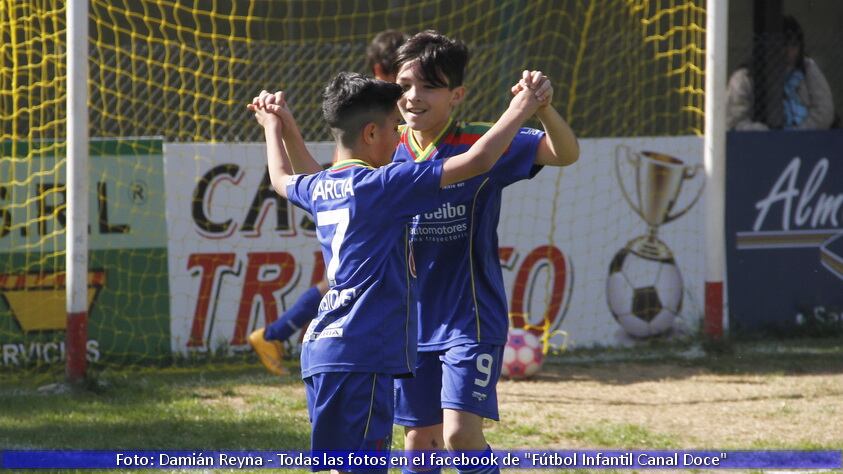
(0, 450), (843, 470)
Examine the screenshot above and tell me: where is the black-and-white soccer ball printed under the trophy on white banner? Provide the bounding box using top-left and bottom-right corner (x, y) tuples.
(606, 246), (682, 338)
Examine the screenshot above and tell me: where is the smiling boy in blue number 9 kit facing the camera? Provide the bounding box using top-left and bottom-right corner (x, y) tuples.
(393, 31), (579, 472)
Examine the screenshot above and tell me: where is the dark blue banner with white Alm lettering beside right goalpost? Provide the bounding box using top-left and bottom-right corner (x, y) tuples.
(726, 130), (843, 335)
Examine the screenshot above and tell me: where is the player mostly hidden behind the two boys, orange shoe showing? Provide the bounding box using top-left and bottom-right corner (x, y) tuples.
(248, 30), (408, 375)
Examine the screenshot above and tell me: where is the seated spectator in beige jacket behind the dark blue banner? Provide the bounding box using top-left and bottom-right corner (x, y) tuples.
(726, 15), (834, 130)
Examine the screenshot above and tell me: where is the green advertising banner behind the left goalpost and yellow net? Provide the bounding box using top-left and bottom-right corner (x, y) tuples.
(0, 139), (170, 368)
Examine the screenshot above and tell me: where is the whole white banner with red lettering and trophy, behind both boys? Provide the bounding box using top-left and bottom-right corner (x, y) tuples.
(165, 137), (704, 352)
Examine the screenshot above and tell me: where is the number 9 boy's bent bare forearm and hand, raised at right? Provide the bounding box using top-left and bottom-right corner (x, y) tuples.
(512, 71), (580, 166)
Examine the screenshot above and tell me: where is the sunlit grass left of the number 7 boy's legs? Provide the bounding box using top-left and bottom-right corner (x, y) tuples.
(0, 366), (309, 450)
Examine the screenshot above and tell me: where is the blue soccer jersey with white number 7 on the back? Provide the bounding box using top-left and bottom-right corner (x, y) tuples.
(287, 160), (442, 378)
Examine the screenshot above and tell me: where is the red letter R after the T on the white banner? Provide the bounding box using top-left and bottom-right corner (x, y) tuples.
(231, 252), (296, 346)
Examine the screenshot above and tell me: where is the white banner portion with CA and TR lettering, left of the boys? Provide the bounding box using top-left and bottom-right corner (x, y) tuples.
(165, 143), (334, 353)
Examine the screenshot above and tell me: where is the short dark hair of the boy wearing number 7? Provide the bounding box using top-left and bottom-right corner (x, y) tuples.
(322, 72), (402, 148)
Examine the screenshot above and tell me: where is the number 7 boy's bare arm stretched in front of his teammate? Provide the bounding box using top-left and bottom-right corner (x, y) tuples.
(440, 77), (540, 187)
